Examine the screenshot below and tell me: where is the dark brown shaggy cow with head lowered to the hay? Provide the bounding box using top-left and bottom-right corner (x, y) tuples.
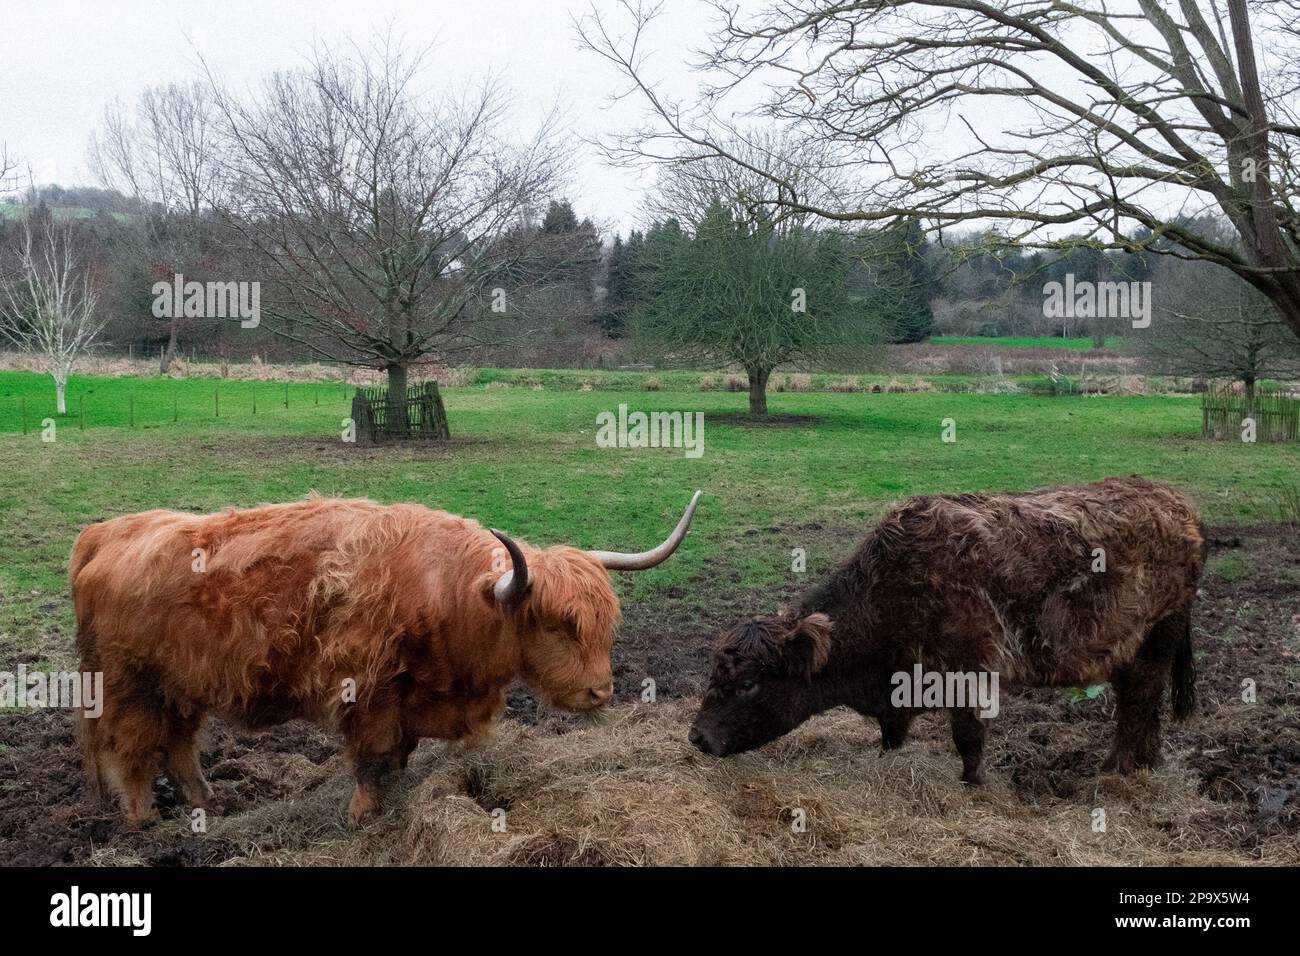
(690, 477), (1205, 783)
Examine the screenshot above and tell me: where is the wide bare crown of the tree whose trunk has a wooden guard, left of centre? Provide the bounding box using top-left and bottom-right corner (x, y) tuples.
(206, 42), (566, 394)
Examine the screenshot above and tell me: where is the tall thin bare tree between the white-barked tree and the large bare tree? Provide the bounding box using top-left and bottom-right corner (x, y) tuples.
(90, 81), (221, 373)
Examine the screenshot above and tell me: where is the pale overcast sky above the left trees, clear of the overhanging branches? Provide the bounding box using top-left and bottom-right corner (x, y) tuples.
(0, 0), (733, 232)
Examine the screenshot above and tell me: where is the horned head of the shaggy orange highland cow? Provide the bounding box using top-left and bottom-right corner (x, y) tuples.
(491, 492), (699, 710)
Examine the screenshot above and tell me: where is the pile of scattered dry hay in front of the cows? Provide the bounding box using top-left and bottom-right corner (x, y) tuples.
(95, 701), (1300, 866)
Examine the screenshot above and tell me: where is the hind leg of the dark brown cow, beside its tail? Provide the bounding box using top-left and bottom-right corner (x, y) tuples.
(1101, 614), (1186, 774)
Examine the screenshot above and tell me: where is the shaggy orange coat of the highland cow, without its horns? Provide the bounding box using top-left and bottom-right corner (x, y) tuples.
(70, 496), (619, 822)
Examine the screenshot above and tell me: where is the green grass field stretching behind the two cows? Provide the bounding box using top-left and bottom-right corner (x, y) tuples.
(0, 372), (1300, 671)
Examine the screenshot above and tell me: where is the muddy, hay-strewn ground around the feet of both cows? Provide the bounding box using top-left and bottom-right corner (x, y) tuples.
(0, 524), (1300, 865)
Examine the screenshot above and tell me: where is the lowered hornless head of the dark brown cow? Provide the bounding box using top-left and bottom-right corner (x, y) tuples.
(690, 614), (831, 757)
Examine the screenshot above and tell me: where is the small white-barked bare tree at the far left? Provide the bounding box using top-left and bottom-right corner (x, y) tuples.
(0, 209), (107, 415)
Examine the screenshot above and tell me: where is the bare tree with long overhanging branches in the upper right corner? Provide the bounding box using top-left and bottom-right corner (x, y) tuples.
(577, 0), (1300, 334)
